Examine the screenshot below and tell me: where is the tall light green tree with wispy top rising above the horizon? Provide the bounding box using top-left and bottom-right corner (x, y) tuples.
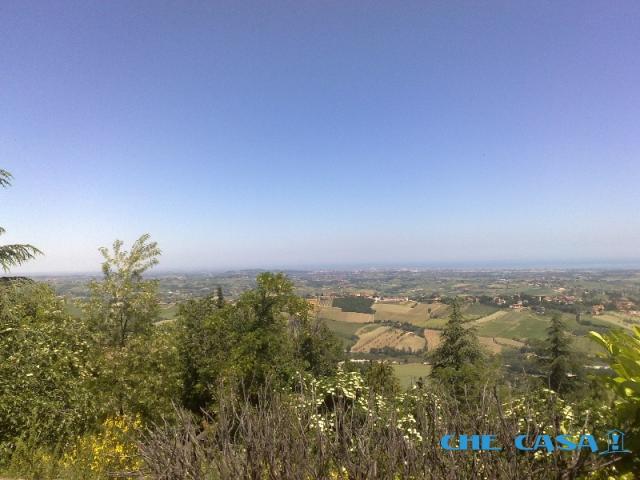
(85, 234), (180, 418)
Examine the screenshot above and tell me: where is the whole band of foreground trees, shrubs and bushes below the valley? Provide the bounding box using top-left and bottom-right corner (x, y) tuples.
(0, 169), (640, 479)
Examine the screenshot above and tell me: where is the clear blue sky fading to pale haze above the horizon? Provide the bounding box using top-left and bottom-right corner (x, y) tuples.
(0, 0), (640, 272)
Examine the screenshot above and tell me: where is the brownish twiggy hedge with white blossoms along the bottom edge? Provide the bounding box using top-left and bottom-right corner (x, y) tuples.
(141, 371), (608, 480)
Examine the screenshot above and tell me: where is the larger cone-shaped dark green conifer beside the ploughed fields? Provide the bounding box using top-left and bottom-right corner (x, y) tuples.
(431, 299), (482, 371)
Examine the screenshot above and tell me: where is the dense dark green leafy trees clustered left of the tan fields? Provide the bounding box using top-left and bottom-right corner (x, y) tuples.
(178, 273), (341, 411)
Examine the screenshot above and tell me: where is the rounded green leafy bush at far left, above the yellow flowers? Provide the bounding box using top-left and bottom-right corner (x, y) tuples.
(0, 282), (96, 460)
